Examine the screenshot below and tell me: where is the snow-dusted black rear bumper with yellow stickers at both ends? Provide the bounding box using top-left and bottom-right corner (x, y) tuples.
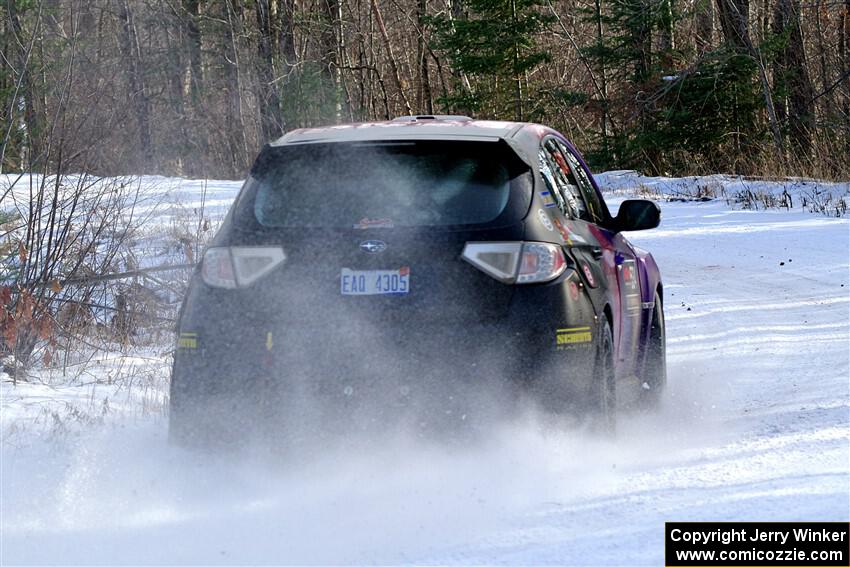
(171, 276), (596, 426)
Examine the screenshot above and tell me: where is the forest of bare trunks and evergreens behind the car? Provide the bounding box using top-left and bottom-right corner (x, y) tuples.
(0, 0), (850, 179)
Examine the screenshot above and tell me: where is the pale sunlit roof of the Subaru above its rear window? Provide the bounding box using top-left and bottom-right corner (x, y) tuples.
(270, 115), (555, 168)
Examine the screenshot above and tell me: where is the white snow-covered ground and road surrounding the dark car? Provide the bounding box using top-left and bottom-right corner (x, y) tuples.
(0, 172), (850, 565)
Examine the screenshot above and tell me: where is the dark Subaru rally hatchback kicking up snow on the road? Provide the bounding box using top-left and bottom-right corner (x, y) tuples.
(170, 116), (666, 441)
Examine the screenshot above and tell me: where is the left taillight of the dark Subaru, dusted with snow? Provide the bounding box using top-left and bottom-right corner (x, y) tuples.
(201, 246), (286, 289)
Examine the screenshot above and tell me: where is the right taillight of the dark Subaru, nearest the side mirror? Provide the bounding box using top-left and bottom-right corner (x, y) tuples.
(462, 242), (567, 284)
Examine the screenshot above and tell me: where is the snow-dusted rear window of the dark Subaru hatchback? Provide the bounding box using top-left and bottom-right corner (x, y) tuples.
(240, 141), (527, 228)
